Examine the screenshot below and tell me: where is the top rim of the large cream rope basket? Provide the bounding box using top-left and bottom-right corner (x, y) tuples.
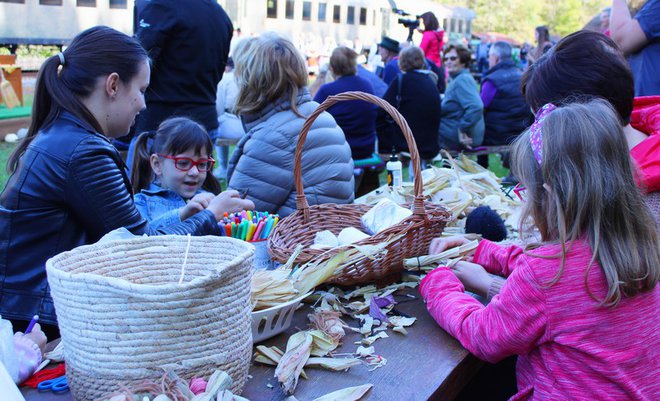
(46, 235), (254, 297)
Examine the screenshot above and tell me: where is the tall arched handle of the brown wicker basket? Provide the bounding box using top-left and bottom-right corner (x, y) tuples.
(293, 91), (426, 223)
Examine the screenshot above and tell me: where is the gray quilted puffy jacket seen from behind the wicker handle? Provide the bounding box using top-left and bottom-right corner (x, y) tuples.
(227, 88), (354, 216)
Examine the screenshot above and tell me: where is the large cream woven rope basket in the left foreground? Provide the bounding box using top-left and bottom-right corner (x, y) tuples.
(46, 235), (254, 401)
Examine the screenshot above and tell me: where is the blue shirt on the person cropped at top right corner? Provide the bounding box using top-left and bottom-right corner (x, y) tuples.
(628, 0), (660, 96)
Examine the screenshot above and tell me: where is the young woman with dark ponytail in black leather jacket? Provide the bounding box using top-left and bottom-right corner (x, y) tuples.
(0, 27), (253, 338)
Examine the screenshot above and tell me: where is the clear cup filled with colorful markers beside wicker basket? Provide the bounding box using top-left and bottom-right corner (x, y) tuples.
(218, 211), (280, 269)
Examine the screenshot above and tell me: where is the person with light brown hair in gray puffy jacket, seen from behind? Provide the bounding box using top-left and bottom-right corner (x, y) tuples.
(227, 34), (354, 216)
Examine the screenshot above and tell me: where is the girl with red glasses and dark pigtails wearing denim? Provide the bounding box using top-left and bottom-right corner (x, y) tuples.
(132, 117), (254, 227)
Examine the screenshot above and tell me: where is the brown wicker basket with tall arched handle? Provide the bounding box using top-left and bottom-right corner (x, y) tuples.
(268, 92), (450, 285)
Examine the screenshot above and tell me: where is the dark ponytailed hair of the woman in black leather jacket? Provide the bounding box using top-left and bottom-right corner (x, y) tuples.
(7, 26), (148, 173)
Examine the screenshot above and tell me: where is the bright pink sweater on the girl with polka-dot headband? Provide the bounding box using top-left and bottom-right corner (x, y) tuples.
(420, 240), (660, 400)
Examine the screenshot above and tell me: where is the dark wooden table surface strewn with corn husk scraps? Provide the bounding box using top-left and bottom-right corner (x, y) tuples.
(23, 291), (483, 401)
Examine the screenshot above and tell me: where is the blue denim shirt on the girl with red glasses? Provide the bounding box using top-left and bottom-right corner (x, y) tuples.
(135, 182), (203, 228)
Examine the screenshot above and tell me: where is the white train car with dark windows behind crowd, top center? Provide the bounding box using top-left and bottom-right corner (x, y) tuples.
(226, 0), (476, 53)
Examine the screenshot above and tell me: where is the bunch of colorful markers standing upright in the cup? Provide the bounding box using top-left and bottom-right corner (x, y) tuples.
(218, 210), (280, 242)
